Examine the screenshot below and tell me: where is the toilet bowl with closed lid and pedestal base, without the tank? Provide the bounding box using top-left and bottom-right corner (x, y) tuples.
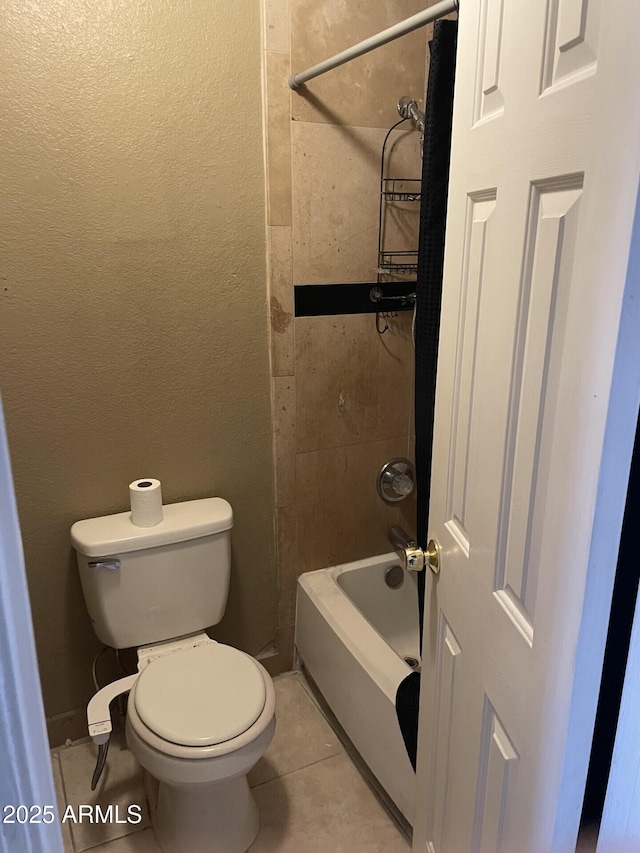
(126, 638), (275, 853)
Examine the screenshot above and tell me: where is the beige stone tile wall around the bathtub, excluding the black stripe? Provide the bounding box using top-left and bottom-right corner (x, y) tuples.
(263, 0), (426, 671)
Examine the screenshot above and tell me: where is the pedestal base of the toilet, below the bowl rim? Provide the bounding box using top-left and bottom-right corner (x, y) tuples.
(152, 776), (260, 853)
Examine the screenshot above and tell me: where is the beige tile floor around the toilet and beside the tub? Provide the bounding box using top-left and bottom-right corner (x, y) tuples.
(52, 673), (411, 853)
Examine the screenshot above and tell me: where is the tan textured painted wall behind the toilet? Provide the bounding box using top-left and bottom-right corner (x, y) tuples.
(0, 0), (275, 736)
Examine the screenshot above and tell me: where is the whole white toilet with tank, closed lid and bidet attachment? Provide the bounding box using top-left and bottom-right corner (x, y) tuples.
(71, 498), (275, 853)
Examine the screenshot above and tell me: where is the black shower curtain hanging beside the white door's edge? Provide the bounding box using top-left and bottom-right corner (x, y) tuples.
(396, 16), (458, 770)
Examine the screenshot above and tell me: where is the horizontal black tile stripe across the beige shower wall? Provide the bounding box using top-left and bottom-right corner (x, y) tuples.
(293, 281), (416, 317)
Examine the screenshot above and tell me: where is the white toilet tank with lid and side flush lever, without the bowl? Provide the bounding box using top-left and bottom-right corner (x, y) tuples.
(71, 498), (233, 649)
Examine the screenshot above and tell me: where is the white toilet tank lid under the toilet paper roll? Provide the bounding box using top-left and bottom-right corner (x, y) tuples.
(71, 498), (233, 557)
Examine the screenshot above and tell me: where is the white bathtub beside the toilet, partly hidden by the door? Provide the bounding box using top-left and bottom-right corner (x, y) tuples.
(295, 554), (419, 825)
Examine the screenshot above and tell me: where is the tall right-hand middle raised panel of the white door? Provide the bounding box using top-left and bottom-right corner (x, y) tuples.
(495, 175), (582, 644)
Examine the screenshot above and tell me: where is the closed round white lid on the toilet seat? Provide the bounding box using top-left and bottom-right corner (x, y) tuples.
(134, 643), (266, 746)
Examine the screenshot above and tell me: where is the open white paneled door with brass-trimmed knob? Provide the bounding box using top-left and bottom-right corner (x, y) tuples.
(414, 0), (640, 853)
